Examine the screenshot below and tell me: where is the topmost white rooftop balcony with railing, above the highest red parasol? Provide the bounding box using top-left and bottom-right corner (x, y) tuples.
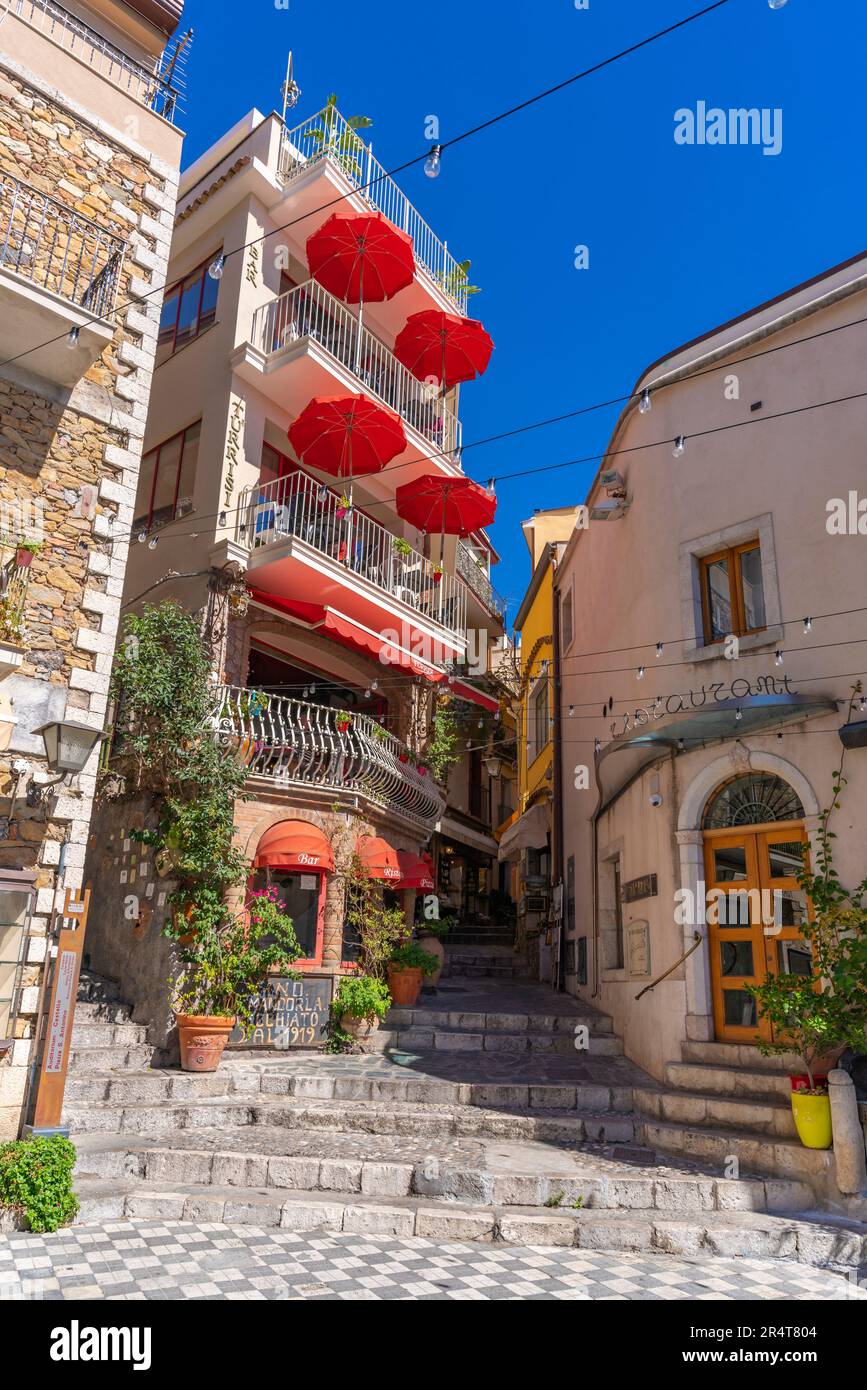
(279, 108), (468, 314)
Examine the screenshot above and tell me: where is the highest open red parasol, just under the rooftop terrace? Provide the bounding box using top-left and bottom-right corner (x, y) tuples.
(307, 213), (415, 304)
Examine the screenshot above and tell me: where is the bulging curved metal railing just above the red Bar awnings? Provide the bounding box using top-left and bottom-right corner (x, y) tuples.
(213, 685), (445, 831)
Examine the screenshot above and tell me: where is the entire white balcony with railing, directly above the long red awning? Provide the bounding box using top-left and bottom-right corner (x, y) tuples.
(235, 471), (467, 664)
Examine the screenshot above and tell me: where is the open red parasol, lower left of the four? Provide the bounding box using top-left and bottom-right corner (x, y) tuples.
(289, 395), (407, 478)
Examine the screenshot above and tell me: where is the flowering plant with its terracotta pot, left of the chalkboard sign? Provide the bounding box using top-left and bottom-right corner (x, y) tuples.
(172, 887), (302, 1072)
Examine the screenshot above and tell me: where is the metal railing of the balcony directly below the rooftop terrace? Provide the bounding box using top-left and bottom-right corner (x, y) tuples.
(251, 279), (461, 457)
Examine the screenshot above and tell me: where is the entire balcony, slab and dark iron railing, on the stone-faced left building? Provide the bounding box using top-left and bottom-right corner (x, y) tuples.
(0, 175), (124, 386)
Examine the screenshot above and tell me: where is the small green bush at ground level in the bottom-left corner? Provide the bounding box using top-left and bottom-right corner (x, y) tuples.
(0, 1134), (78, 1232)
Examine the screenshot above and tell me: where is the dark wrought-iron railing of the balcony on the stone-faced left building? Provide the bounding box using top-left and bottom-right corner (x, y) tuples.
(0, 174), (124, 318)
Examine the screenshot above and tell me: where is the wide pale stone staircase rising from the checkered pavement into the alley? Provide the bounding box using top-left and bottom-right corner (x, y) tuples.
(65, 977), (867, 1268)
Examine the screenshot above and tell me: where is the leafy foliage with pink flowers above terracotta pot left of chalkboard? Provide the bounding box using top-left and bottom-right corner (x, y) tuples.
(172, 887), (303, 1033)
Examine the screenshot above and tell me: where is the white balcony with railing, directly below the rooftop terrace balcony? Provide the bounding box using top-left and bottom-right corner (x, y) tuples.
(232, 279), (461, 482)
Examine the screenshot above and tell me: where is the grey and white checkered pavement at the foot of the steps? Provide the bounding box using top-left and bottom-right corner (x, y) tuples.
(0, 1220), (867, 1302)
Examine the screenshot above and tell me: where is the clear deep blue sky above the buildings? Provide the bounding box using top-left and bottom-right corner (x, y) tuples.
(176, 0), (867, 619)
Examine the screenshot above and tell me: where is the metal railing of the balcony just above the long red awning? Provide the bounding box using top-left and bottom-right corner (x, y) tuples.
(236, 471), (467, 641)
